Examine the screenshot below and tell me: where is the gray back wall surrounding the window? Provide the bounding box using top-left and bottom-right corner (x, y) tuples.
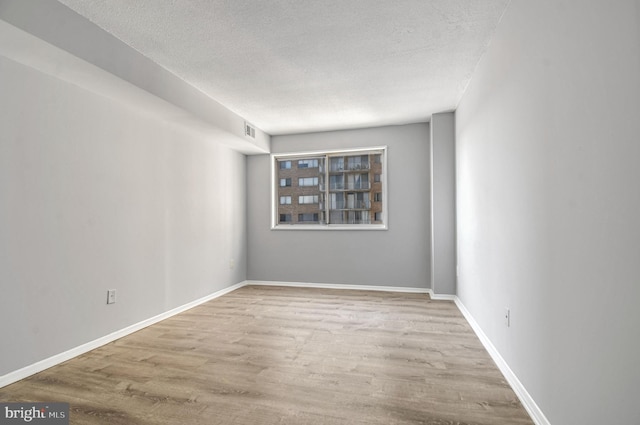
(247, 123), (431, 288)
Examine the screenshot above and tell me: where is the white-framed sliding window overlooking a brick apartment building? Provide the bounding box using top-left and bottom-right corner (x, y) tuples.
(272, 147), (388, 230)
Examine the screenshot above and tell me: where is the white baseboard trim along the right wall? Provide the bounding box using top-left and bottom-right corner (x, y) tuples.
(454, 296), (551, 425)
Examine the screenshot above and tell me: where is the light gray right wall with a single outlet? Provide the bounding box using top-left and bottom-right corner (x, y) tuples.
(456, 0), (640, 425)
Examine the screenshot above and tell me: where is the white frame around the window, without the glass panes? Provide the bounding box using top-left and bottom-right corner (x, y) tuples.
(271, 146), (389, 231)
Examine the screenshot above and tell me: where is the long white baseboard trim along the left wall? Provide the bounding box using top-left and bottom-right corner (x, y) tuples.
(0, 281), (246, 388)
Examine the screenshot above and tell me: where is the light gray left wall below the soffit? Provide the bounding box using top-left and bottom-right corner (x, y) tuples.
(0, 55), (247, 375)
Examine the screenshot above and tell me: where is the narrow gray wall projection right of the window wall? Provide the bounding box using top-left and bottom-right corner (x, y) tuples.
(431, 112), (456, 295)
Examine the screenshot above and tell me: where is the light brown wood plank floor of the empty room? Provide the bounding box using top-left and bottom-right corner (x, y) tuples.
(0, 286), (533, 425)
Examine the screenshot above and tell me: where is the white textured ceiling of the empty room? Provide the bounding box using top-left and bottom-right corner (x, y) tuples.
(59, 0), (509, 135)
